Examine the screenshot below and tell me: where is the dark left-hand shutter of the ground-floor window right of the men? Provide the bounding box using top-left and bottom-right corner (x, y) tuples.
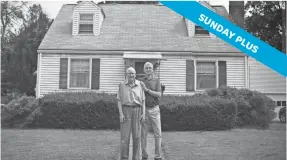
(186, 60), (194, 91)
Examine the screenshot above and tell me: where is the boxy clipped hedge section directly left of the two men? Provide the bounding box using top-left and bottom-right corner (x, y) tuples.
(32, 92), (119, 129)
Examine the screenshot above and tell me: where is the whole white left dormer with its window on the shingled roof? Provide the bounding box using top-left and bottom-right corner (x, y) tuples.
(72, 1), (105, 36)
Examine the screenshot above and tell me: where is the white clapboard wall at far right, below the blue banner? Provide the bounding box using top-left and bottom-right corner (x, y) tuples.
(248, 57), (286, 94)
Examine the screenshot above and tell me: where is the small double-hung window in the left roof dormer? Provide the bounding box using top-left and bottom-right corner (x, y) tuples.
(79, 14), (94, 34)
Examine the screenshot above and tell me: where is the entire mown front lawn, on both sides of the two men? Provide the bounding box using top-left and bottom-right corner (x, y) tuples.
(1, 122), (286, 160)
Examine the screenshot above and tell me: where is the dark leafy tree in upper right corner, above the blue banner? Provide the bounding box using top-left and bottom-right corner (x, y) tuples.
(245, 1), (286, 51)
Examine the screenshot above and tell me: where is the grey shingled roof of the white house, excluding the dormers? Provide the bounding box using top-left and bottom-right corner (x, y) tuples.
(38, 4), (240, 53)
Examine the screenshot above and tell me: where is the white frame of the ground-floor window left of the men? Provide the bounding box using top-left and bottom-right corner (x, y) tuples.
(67, 57), (92, 89)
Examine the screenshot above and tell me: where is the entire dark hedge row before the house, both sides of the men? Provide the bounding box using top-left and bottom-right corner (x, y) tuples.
(1, 87), (275, 131)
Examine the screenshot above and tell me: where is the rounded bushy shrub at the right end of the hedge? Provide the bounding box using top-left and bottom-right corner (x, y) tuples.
(206, 87), (276, 128)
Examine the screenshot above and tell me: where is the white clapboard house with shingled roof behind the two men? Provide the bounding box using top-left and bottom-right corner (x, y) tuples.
(36, 1), (250, 97)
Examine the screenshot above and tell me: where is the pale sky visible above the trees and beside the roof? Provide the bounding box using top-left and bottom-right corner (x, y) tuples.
(31, 0), (232, 19)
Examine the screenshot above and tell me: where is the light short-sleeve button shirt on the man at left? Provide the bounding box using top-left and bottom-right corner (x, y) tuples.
(117, 80), (145, 106)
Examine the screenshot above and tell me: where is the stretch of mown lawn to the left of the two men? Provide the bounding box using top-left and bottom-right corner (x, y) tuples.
(1, 129), (120, 160)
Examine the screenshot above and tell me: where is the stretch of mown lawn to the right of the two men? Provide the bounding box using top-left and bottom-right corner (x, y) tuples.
(163, 122), (286, 160)
